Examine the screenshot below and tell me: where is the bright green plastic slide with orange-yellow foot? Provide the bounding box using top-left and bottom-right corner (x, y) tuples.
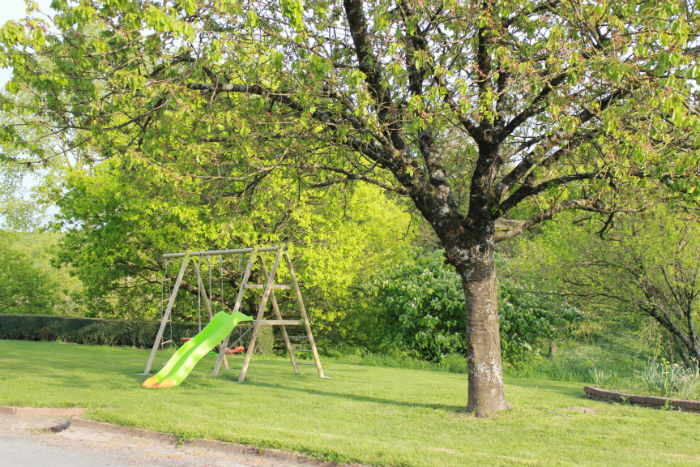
(142, 311), (253, 388)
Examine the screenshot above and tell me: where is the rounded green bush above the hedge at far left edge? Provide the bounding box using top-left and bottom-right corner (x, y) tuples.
(0, 232), (59, 313)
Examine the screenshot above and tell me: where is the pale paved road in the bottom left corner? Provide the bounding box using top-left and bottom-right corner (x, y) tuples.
(0, 414), (308, 467)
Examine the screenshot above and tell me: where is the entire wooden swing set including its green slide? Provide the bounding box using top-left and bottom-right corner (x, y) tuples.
(143, 246), (325, 387)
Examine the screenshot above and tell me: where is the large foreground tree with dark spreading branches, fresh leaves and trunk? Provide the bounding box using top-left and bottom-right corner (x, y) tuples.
(0, 0), (700, 416)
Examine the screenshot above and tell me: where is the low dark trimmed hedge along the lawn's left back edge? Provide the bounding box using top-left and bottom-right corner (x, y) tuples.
(0, 314), (206, 348)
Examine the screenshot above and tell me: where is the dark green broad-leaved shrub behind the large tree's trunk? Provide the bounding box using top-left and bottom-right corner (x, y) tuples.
(360, 250), (582, 364)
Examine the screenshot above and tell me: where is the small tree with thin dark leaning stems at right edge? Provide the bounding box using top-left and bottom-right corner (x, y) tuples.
(548, 206), (700, 367)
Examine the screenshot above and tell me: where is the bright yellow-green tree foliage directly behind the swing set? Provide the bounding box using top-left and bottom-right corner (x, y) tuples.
(51, 150), (412, 330)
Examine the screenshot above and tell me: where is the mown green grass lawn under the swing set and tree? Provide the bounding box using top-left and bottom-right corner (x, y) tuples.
(0, 340), (700, 466)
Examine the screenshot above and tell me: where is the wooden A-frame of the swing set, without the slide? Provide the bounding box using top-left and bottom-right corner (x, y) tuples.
(143, 245), (326, 383)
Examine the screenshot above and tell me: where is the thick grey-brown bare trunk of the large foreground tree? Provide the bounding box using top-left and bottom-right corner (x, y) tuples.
(456, 242), (509, 417)
